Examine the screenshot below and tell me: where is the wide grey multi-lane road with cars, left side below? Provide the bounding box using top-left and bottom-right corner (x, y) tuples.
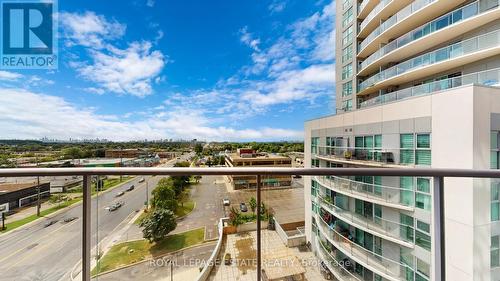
(0, 153), (193, 281)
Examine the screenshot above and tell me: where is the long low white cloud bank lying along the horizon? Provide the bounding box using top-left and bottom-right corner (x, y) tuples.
(0, 89), (302, 141)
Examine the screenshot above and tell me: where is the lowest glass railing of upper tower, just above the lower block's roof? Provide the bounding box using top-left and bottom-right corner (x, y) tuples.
(359, 68), (500, 108)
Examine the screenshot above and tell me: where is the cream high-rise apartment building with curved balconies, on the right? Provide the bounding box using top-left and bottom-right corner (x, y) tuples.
(304, 0), (500, 281)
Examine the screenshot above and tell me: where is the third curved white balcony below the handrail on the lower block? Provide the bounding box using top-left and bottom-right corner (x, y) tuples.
(316, 212), (409, 281)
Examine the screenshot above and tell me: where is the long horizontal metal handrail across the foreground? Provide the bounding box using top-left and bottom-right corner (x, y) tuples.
(0, 166), (500, 178)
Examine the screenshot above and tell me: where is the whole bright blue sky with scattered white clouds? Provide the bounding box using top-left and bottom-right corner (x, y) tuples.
(0, 0), (335, 141)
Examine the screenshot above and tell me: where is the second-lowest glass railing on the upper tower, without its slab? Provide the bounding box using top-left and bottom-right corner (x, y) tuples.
(359, 27), (500, 91)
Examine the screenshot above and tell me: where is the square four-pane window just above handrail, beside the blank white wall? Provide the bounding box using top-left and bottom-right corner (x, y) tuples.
(399, 134), (431, 165)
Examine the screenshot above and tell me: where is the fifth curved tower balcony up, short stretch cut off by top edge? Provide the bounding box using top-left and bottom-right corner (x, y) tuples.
(358, 0), (411, 38)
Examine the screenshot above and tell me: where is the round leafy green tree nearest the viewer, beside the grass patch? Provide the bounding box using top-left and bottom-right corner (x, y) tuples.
(140, 209), (177, 243)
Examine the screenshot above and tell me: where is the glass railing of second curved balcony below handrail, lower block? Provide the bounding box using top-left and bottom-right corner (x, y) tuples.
(318, 192), (414, 243)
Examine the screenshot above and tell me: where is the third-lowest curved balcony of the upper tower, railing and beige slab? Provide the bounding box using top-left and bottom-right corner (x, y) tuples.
(358, 0), (500, 75)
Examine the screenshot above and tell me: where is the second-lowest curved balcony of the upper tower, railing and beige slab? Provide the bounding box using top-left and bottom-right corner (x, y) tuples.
(358, 30), (500, 95)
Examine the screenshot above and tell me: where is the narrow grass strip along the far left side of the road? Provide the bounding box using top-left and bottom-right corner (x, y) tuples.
(0, 177), (134, 234)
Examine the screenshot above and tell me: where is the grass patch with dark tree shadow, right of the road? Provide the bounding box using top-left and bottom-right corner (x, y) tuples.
(92, 228), (205, 276)
